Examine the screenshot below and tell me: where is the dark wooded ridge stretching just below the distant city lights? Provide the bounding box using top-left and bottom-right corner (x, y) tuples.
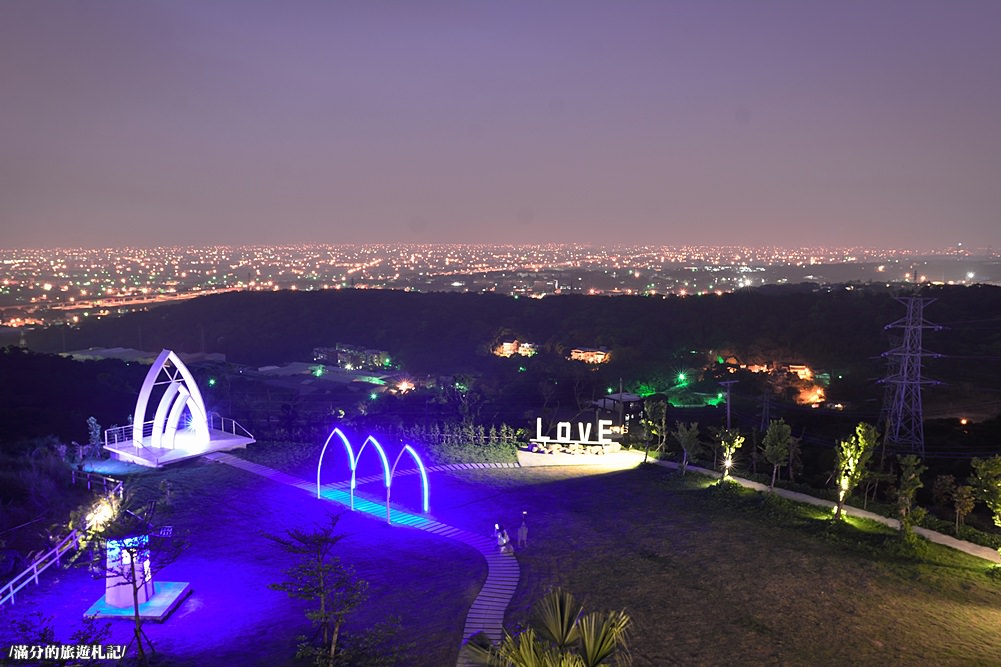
(21, 285), (1001, 410)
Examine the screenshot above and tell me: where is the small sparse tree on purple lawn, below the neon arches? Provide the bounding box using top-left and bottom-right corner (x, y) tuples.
(265, 515), (368, 667)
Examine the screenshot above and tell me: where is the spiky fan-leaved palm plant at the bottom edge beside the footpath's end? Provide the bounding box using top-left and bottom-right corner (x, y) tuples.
(467, 588), (632, 667)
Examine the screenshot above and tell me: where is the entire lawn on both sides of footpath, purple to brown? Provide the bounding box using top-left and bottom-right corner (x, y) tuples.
(0, 448), (1001, 666)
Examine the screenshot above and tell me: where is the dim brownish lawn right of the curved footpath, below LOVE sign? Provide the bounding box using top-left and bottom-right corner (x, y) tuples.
(433, 467), (1001, 665)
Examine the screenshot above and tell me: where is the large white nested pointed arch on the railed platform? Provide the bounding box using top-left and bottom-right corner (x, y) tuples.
(132, 350), (210, 450)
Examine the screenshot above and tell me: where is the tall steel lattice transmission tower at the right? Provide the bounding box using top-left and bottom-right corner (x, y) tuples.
(882, 296), (942, 458)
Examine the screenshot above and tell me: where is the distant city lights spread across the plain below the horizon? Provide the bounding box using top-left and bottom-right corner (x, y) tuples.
(0, 244), (1001, 326)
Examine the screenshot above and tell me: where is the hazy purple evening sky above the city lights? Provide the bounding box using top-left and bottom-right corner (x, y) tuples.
(0, 0), (1001, 249)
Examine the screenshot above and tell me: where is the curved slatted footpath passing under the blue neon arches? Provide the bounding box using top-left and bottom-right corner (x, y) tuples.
(205, 452), (521, 667)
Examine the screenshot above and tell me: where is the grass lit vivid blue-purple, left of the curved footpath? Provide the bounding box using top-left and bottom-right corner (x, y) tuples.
(0, 462), (486, 667)
